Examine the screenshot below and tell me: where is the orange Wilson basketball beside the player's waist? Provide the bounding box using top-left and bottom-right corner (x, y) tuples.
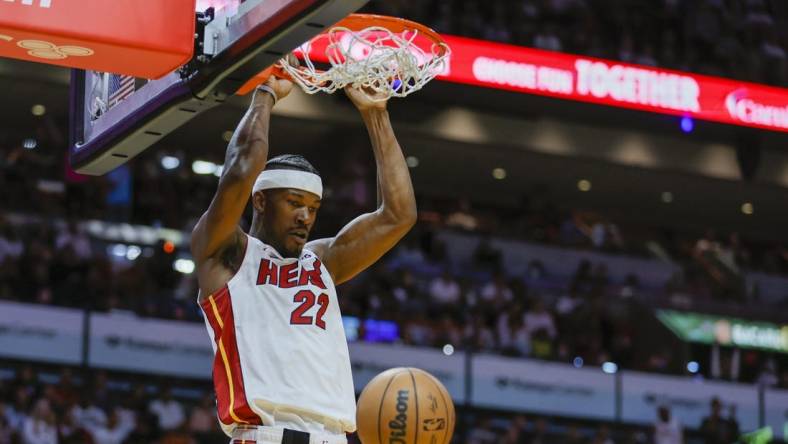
(356, 367), (455, 444)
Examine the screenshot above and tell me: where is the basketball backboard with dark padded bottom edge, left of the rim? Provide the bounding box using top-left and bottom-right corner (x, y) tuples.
(69, 0), (367, 175)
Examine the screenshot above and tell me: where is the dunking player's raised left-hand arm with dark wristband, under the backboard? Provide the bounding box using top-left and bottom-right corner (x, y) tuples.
(191, 77), (292, 265)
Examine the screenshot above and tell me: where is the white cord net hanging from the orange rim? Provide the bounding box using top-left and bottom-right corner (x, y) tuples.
(280, 26), (450, 101)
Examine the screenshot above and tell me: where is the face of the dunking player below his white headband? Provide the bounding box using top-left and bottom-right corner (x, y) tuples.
(263, 188), (320, 257)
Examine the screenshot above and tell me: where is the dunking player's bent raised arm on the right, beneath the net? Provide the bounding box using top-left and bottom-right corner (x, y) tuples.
(309, 88), (416, 284)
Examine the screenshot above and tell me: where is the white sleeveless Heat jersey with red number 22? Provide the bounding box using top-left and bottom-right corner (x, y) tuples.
(200, 236), (356, 434)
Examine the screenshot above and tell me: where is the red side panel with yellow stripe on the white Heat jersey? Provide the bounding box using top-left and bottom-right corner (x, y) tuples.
(200, 285), (262, 425)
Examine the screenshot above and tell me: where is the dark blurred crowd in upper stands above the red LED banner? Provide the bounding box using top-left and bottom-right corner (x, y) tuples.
(372, 0), (788, 86)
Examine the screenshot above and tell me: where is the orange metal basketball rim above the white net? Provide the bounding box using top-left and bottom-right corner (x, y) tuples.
(235, 14), (445, 96)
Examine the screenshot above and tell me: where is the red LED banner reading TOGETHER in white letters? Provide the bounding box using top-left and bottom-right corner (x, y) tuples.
(298, 35), (788, 132)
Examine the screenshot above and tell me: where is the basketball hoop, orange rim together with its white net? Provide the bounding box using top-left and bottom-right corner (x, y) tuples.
(239, 14), (451, 101)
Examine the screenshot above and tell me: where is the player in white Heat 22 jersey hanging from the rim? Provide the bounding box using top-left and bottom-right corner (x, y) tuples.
(191, 72), (416, 444)
